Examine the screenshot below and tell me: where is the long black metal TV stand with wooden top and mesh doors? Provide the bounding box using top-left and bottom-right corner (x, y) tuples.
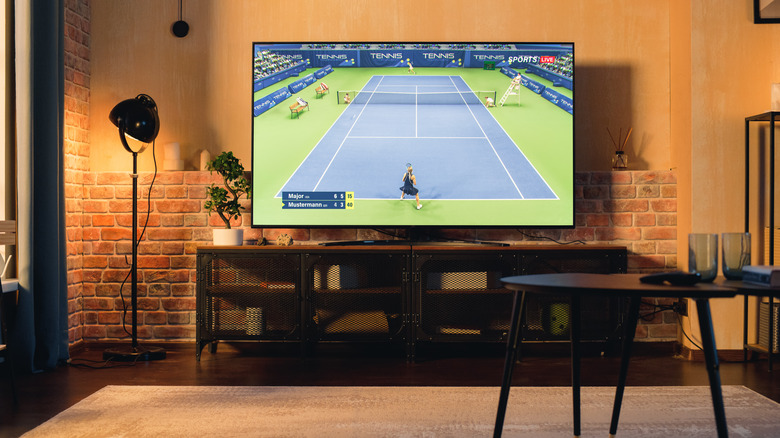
(196, 241), (627, 361)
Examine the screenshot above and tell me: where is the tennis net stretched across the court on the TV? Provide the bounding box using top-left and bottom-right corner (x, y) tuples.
(336, 90), (496, 105)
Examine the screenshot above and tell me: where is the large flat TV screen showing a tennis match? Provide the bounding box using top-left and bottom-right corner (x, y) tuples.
(251, 42), (574, 227)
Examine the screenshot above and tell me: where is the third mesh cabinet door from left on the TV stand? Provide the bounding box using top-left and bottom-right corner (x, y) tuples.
(414, 252), (516, 342)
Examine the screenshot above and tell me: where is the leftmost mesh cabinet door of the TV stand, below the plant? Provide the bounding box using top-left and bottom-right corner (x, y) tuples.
(197, 253), (301, 356)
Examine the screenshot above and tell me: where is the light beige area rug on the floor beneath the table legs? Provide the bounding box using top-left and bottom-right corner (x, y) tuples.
(24, 386), (780, 438)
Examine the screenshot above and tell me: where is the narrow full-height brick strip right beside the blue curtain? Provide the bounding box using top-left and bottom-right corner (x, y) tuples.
(63, 0), (90, 343)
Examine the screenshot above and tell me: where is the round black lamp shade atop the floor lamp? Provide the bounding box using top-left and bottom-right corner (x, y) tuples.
(108, 94), (160, 153)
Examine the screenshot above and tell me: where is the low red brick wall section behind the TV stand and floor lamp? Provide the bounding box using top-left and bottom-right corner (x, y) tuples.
(69, 171), (677, 341)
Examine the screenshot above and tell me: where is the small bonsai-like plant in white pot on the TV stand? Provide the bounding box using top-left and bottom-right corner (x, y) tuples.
(204, 151), (252, 246)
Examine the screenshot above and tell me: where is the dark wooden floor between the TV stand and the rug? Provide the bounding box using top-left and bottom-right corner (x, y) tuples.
(0, 344), (780, 437)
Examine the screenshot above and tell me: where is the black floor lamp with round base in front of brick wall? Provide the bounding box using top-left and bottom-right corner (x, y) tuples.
(103, 94), (165, 361)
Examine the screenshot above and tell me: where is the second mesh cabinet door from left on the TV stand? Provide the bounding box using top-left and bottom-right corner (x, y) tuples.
(304, 252), (408, 342)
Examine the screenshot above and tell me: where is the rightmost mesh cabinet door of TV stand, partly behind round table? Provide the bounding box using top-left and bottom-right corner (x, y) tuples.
(520, 249), (626, 342)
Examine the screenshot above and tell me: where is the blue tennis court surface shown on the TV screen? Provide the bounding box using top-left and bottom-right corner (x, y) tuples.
(276, 76), (558, 200)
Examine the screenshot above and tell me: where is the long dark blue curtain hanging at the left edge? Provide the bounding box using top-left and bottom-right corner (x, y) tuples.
(10, 0), (68, 372)
